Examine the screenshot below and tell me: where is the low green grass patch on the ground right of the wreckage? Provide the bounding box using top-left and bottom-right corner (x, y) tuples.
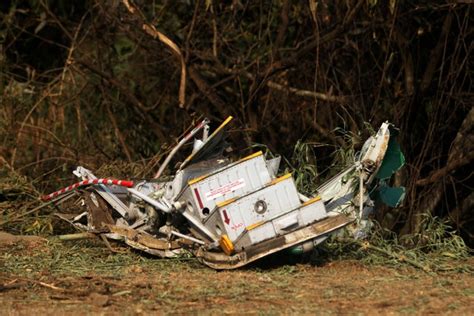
(317, 216), (474, 273)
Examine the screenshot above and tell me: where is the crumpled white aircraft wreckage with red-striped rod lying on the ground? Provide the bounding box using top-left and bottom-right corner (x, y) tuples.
(43, 117), (404, 269)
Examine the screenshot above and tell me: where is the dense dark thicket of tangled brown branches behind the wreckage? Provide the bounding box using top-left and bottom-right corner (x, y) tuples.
(0, 0), (474, 245)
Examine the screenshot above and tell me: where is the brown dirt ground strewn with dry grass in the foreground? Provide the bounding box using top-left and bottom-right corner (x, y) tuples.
(0, 236), (474, 315)
